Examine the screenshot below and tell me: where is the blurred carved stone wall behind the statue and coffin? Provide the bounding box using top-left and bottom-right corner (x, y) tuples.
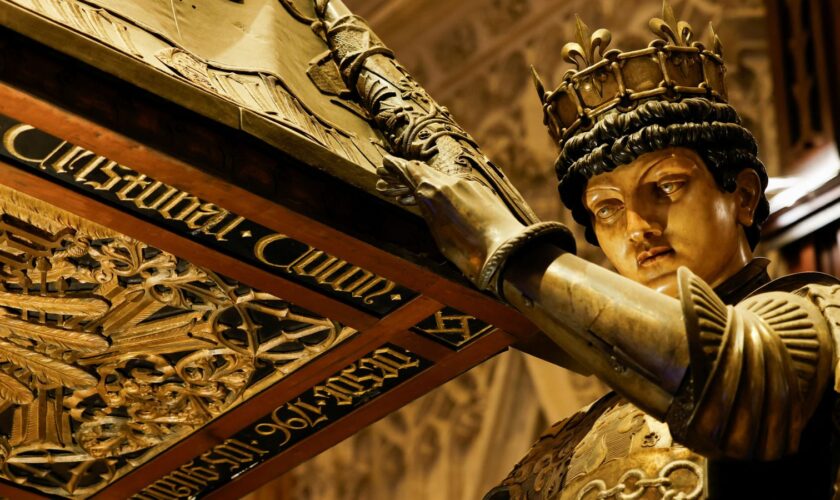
(243, 0), (780, 500)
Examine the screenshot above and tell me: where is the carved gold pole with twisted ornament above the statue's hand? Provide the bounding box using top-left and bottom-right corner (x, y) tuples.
(315, 0), (539, 225)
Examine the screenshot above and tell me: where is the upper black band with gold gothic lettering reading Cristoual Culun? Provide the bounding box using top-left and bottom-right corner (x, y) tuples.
(0, 115), (417, 316)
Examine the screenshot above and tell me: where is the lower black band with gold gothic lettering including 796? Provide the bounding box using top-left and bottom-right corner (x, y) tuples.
(132, 345), (431, 500)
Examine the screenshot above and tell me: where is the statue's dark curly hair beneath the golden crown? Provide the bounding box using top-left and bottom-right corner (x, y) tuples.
(555, 97), (770, 248)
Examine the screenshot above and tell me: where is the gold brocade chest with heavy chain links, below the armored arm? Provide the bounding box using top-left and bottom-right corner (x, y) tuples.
(492, 394), (708, 500)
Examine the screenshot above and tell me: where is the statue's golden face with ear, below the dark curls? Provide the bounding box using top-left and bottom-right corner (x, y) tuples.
(583, 148), (760, 296)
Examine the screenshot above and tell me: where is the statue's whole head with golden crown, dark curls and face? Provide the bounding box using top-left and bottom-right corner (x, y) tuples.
(534, 2), (768, 295)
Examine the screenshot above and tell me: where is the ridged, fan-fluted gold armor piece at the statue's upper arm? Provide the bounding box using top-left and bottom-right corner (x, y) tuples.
(668, 269), (840, 460)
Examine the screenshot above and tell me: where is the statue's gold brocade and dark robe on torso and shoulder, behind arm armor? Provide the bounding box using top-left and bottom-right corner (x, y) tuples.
(484, 259), (840, 500)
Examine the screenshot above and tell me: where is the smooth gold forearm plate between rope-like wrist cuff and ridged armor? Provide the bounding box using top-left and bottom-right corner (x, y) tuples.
(504, 245), (688, 418)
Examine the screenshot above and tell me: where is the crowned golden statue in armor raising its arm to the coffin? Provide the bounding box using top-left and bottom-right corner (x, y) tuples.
(321, 2), (840, 500)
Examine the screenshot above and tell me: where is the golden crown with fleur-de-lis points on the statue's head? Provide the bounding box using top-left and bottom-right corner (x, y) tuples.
(531, 0), (726, 148)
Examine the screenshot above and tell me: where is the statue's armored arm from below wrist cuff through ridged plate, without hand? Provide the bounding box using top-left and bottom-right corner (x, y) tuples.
(502, 244), (833, 460)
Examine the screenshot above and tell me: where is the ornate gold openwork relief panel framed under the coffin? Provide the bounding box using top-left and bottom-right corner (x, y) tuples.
(0, 187), (353, 497)
